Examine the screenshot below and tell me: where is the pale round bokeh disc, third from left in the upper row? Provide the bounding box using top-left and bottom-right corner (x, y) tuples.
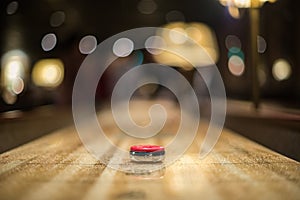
(112, 38), (134, 57)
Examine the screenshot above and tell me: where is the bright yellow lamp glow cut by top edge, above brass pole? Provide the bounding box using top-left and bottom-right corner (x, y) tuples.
(219, 0), (276, 8)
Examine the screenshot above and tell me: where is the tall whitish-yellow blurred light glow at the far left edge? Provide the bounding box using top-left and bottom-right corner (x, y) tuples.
(1, 50), (29, 104)
